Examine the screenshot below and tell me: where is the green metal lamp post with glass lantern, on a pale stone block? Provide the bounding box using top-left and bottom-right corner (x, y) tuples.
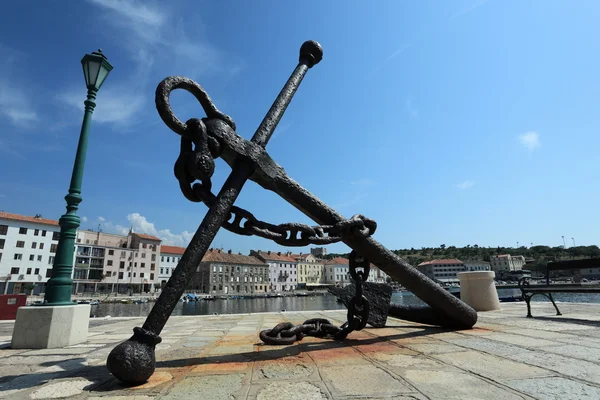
(44, 50), (113, 306)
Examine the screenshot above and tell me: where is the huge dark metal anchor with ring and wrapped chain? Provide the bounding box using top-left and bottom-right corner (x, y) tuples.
(107, 41), (477, 384)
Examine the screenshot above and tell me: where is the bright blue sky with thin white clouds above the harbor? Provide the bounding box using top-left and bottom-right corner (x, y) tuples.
(0, 0), (600, 252)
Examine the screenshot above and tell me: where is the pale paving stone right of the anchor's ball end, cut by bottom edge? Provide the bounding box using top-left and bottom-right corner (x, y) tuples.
(161, 374), (243, 400)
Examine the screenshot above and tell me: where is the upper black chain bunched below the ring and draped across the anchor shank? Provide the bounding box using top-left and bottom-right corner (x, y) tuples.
(174, 118), (377, 247)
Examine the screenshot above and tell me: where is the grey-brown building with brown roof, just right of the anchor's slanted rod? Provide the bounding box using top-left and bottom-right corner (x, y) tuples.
(188, 249), (269, 295)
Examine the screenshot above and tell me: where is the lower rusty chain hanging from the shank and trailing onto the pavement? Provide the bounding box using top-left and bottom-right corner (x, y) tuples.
(259, 250), (371, 345)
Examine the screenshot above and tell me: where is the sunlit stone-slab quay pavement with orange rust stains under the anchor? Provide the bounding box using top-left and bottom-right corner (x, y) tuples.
(0, 302), (600, 400)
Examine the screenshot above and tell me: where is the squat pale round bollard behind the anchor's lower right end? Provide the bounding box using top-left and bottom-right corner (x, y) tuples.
(457, 271), (500, 311)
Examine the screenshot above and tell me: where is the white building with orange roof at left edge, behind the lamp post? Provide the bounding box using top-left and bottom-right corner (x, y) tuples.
(0, 212), (60, 294)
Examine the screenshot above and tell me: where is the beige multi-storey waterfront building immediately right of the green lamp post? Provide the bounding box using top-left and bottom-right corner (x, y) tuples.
(73, 230), (161, 293)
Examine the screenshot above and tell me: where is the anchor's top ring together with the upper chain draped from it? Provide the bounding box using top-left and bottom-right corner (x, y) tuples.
(156, 77), (377, 247)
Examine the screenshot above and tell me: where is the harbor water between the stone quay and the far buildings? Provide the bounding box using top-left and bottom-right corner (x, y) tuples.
(91, 289), (600, 317)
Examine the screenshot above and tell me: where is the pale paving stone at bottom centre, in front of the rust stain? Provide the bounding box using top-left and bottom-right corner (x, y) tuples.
(320, 364), (414, 397)
